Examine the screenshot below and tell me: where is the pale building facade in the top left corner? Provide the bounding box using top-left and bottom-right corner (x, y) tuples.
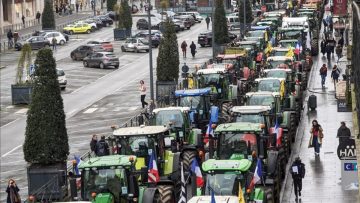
(0, 0), (44, 34)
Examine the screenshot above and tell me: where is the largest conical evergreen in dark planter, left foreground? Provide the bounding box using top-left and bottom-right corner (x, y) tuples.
(23, 49), (69, 199)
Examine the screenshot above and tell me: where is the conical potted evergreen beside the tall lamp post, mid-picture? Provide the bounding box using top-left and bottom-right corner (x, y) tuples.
(156, 19), (180, 106)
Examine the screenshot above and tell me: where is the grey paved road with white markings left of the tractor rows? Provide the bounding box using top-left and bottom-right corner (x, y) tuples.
(0, 19), (211, 201)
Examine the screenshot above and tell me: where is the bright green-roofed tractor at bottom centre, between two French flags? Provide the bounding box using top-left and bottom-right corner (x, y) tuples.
(188, 159), (274, 203)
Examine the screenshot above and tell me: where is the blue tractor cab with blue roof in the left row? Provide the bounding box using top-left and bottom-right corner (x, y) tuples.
(175, 88), (211, 129)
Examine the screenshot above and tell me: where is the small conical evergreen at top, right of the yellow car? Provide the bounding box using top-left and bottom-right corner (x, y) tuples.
(114, 0), (132, 40)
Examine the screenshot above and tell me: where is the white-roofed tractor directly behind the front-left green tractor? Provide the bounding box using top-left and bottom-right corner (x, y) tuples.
(108, 125), (180, 203)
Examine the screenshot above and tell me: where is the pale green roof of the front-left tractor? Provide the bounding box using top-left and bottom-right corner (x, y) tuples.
(79, 155), (136, 169)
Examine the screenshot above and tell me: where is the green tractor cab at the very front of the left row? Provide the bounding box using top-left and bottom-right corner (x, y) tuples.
(78, 155), (142, 203)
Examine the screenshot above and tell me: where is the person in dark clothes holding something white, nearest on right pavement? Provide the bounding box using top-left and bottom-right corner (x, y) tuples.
(290, 157), (305, 201)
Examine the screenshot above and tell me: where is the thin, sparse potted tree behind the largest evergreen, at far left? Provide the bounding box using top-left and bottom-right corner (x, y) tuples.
(11, 44), (33, 105)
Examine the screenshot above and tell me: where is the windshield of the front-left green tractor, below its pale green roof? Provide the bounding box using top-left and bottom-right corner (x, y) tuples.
(81, 168), (127, 202)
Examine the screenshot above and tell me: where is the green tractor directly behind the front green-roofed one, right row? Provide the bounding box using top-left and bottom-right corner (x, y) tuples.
(209, 122), (286, 202)
